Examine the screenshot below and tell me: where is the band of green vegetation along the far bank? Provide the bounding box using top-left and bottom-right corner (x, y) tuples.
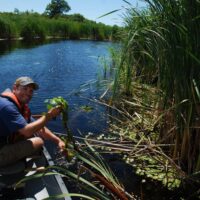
(0, 11), (121, 41)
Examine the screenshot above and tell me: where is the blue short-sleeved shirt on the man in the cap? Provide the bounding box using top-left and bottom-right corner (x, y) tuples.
(0, 97), (27, 136)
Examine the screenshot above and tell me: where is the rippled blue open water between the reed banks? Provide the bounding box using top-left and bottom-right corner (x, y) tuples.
(0, 40), (112, 135)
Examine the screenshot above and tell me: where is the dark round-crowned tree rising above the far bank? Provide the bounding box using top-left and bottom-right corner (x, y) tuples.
(45, 0), (71, 18)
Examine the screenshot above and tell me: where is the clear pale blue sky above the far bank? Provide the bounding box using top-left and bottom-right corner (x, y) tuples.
(0, 0), (144, 26)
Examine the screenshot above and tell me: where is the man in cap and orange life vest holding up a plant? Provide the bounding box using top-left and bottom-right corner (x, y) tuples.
(0, 77), (65, 167)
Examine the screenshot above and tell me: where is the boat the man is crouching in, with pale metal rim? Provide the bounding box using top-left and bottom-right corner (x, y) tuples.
(0, 147), (71, 200)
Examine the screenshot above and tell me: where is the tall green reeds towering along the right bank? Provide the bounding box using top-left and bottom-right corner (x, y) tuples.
(111, 0), (200, 173)
